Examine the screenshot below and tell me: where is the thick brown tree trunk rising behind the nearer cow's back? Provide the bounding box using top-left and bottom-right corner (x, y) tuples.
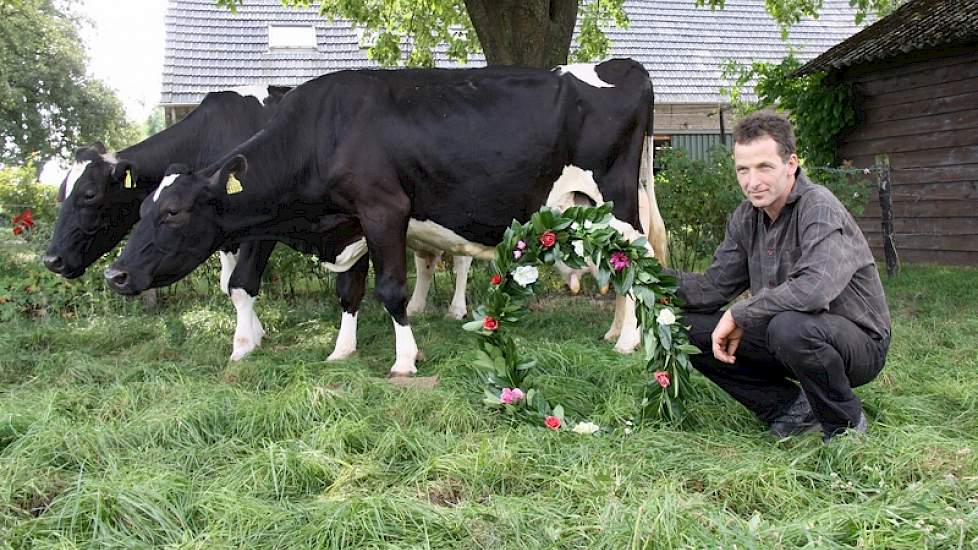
(464, 0), (578, 69)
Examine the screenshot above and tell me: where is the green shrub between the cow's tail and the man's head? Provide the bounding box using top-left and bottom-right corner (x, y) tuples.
(655, 145), (744, 271)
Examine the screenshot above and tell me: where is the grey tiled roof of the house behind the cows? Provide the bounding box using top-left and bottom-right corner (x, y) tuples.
(161, 0), (859, 105)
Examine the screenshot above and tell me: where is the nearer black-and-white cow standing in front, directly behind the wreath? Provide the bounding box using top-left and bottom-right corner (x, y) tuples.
(105, 60), (661, 375)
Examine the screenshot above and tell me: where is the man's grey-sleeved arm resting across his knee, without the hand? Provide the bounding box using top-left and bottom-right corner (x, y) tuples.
(730, 202), (863, 328)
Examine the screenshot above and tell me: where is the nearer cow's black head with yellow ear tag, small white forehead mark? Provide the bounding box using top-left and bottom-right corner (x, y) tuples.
(105, 155), (247, 295)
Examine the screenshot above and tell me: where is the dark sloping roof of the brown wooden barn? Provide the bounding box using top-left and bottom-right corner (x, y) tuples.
(796, 0), (978, 74)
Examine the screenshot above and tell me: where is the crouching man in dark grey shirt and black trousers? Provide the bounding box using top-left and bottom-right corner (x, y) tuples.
(676, 113), (890, 443)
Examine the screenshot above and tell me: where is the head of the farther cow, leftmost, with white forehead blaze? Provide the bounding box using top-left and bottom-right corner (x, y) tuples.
(43, 143), (141, 279)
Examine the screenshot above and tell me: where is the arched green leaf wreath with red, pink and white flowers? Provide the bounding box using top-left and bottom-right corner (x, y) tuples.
(464, 203), (699, 433)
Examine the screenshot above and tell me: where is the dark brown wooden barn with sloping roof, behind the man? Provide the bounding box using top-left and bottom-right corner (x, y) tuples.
(798, 0), (978, 265)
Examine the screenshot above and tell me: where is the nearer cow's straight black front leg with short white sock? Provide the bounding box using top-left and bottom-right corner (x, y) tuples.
(360, 205), (418, 376)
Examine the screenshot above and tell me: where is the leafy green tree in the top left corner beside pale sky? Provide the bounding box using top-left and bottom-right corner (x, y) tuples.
(0, 0), (138, 163)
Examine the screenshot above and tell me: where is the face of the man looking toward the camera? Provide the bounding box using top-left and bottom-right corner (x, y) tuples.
(734, 136), (798, 218)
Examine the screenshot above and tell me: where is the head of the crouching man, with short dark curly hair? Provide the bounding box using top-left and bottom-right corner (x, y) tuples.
(733, 113), (798, 219)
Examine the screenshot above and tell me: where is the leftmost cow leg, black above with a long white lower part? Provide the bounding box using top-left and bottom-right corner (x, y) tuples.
(221, 241), (276, 361)
